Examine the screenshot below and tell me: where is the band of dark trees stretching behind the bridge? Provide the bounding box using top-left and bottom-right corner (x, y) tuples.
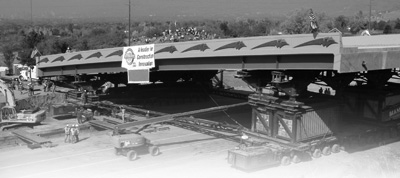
(0, 9), (400, 69)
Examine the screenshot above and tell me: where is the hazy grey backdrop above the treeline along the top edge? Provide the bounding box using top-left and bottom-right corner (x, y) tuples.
(0, 0), (400, 20)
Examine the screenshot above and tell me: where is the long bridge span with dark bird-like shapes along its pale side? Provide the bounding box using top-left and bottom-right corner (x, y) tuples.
(37, 33), (400, 76)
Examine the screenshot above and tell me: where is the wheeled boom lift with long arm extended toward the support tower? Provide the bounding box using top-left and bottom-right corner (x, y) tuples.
(89, 103), (247, 161)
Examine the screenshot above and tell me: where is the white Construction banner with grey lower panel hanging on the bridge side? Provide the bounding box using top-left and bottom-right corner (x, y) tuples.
(121, 44), (155, 83)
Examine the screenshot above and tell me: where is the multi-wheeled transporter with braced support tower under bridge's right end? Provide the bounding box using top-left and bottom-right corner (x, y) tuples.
(228, 87), (400, 171)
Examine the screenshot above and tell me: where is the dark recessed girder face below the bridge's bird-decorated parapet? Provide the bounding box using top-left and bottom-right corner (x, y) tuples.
(39, 54), (334, 77)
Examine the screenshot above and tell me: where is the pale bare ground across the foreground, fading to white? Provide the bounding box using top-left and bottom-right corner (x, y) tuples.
(0, 75), (400, 178)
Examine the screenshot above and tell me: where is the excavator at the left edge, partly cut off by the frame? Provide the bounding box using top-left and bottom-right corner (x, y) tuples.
(0, 81), (46, 131)
